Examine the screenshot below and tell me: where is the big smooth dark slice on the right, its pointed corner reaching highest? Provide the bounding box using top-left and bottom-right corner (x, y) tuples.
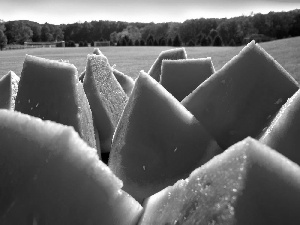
(182, 42), (299, 149)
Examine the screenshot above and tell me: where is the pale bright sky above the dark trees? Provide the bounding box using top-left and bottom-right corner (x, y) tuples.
(0, 0), (300, 24)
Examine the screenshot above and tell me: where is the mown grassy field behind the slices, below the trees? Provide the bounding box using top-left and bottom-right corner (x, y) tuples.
(0, 37), (300, 82)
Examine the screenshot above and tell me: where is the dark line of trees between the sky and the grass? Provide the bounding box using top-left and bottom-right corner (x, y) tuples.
(0, 9), (300, 48)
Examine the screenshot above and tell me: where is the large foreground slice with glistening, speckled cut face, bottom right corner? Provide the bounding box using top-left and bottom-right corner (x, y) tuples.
(139, 138), (300, 225)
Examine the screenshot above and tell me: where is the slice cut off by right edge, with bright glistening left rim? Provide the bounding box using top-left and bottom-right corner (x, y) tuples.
(260, 90), (300, 165)
